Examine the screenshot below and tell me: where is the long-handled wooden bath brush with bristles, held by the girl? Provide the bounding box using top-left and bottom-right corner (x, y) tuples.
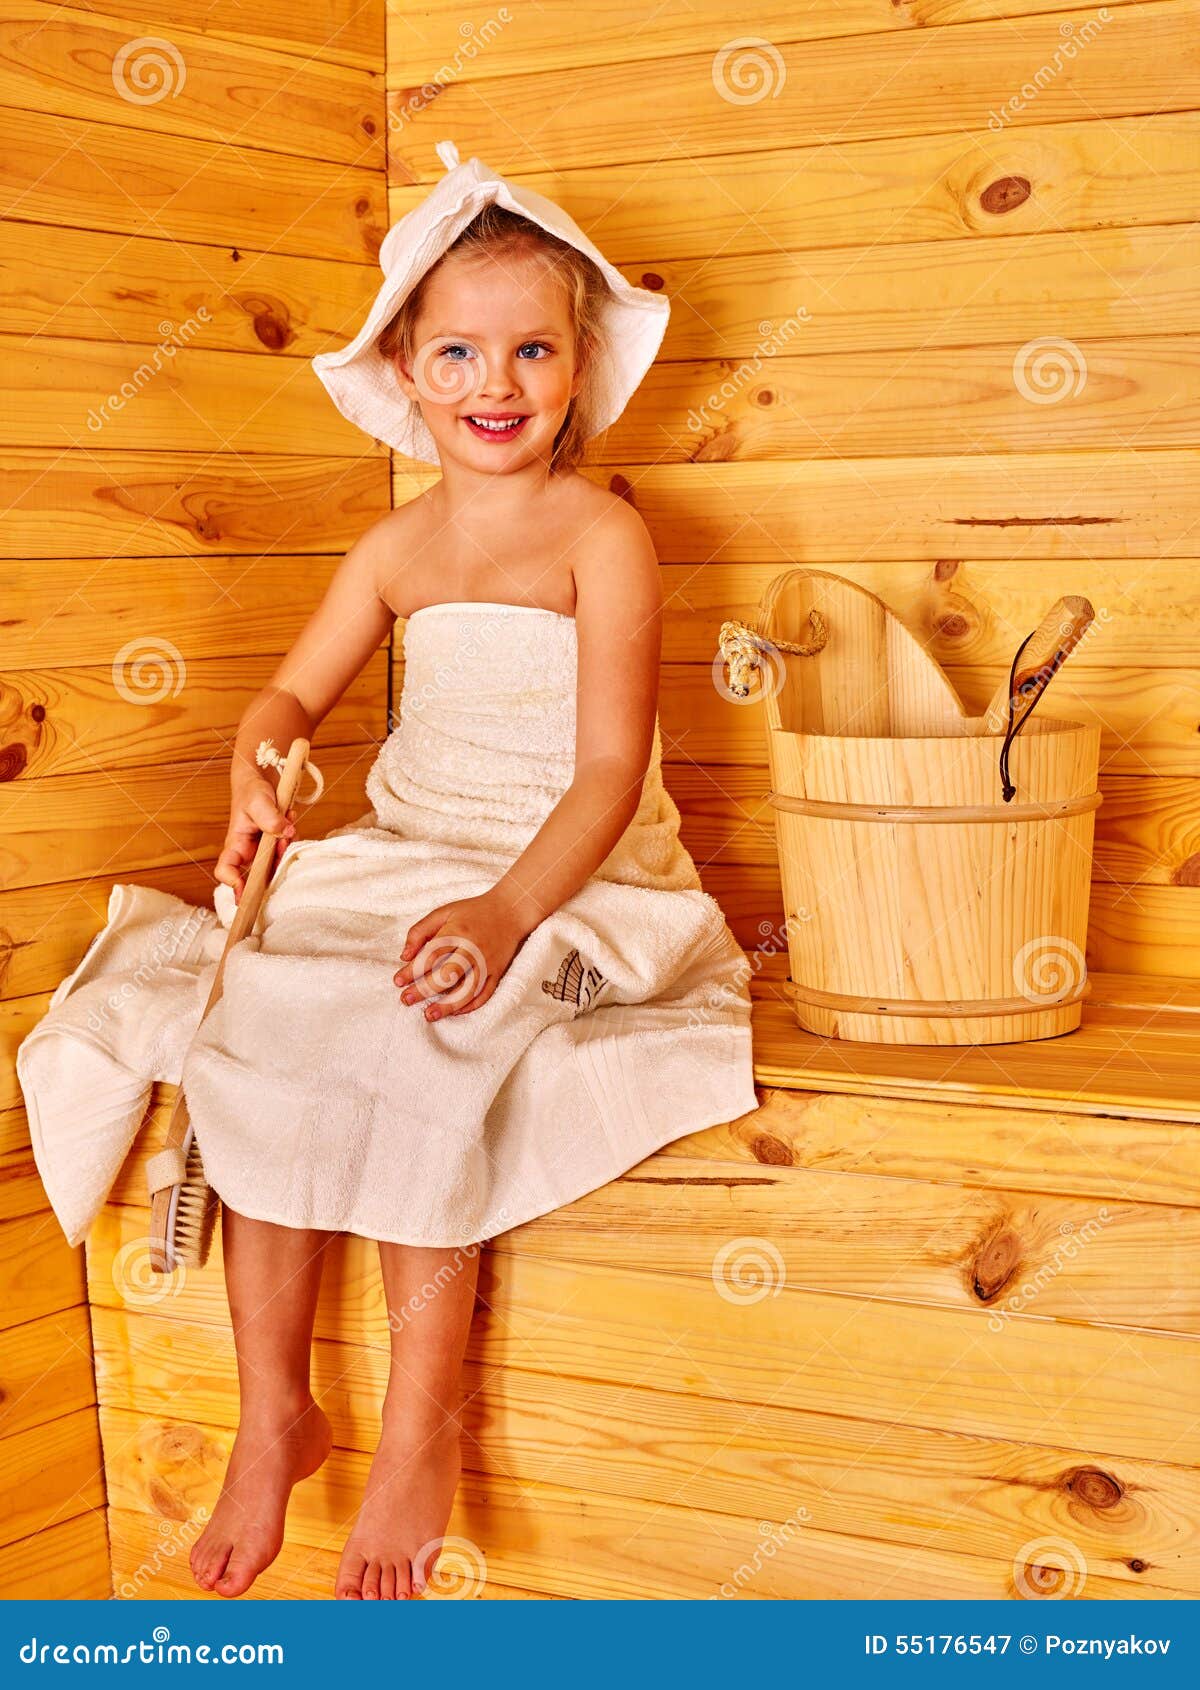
(145, 739), (325, 1273)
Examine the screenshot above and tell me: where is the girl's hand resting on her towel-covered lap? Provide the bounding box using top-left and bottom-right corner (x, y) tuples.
(394, 892), (526, 1021)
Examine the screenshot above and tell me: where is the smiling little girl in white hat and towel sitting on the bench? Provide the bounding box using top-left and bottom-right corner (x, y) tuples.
(184, 144), (757, 1599)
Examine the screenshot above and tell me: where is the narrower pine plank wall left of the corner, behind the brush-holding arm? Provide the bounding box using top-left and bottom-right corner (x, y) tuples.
(0, 0), (389, 1597)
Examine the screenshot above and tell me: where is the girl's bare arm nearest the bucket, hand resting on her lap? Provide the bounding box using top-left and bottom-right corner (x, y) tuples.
(394, 504), (663, 1019)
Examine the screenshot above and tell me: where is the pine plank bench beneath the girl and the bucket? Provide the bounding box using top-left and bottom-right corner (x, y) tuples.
(72, 968), (1200, 1599)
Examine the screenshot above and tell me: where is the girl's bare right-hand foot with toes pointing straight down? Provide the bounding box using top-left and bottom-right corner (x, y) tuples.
(341, 1415), (463, 1600)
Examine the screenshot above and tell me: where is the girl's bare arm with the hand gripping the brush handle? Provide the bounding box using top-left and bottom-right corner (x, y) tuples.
(213, 512), (395, 897)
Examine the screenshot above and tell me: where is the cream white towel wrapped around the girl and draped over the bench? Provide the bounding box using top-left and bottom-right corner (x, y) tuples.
(17, 602), (757, 1246)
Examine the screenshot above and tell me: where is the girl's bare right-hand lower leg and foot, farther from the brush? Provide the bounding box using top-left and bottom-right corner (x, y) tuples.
(335, 1242), (478, 1599)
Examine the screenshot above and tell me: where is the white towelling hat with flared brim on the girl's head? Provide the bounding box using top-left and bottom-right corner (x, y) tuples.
(313, 140), (671, 463)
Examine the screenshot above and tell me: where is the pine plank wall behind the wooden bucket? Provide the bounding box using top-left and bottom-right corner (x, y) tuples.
(389, 0), (1200, 979)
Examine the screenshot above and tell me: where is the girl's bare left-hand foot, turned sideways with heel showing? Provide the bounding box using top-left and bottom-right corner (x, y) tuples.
(189, 1399), (333, 1595)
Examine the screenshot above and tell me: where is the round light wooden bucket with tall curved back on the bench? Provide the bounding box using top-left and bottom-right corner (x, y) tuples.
(759, 570), (1100, 1044)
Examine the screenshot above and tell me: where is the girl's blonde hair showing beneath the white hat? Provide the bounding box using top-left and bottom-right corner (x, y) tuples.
(377, 201), (610, 475)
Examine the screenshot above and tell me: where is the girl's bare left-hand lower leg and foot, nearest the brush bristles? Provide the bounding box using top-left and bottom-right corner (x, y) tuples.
(191, 1205), (336, 1595)
